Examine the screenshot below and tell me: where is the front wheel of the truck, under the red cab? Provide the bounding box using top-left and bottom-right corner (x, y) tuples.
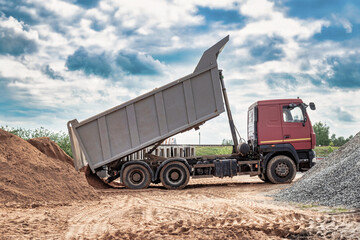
(266, 155), (296, 183)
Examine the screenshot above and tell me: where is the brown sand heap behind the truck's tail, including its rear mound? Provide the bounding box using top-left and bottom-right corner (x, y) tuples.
(0, 129), (98, 206)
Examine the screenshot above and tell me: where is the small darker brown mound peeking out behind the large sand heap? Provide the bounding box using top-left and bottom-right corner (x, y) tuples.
(28, 137), (74, 166)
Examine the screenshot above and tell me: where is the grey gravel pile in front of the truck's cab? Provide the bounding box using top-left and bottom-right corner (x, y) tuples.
(274, 132), (360, 208)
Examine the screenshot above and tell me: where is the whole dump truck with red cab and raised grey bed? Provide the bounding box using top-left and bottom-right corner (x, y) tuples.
(67, 36), (316, 189)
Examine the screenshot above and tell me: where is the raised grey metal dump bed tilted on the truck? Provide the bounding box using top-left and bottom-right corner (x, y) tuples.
(68, 36), (229, 171)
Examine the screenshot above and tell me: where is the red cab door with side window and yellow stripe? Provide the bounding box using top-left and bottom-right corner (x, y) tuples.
(281, 104), (311, 150)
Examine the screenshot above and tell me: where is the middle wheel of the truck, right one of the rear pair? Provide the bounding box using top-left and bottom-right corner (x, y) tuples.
(160, 161), (190, 189)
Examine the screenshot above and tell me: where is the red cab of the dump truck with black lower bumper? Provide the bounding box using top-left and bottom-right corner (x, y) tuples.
(248, 98), (316, 182)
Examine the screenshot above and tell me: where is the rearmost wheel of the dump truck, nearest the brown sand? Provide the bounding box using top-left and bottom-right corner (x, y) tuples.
(121, 164), (151, 189)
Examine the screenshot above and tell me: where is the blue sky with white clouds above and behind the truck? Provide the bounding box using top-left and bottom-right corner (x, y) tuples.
(0, 0), (360, 143)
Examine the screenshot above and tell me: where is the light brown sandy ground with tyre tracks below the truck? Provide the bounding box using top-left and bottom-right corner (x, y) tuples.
(0, 176), (360, 239)
